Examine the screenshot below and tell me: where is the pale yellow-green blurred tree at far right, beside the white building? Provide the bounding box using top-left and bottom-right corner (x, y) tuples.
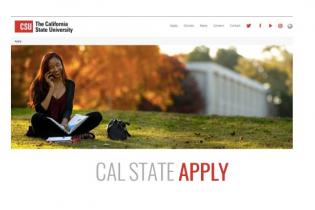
(235, 45), (293, 117)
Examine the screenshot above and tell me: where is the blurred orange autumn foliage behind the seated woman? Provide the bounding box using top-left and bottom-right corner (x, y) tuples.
(11, 45), (188, 110)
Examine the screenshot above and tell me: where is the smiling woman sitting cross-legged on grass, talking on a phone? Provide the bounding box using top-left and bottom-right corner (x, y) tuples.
(27, 52), (102, 139)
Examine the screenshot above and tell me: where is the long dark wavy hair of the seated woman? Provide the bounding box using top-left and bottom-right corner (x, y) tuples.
(28, 52), (67, 107)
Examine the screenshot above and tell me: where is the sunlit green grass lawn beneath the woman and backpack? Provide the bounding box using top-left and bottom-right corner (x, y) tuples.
(11, 108), (293, 149)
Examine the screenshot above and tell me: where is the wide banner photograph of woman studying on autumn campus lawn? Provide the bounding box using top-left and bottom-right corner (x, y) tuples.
(11, 45), (293, 149)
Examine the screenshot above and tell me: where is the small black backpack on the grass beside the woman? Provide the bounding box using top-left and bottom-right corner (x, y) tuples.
(107, 119), (131, 140)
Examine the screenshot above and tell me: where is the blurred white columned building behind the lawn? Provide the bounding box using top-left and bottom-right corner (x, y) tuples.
(187, 62), (268, 117)
